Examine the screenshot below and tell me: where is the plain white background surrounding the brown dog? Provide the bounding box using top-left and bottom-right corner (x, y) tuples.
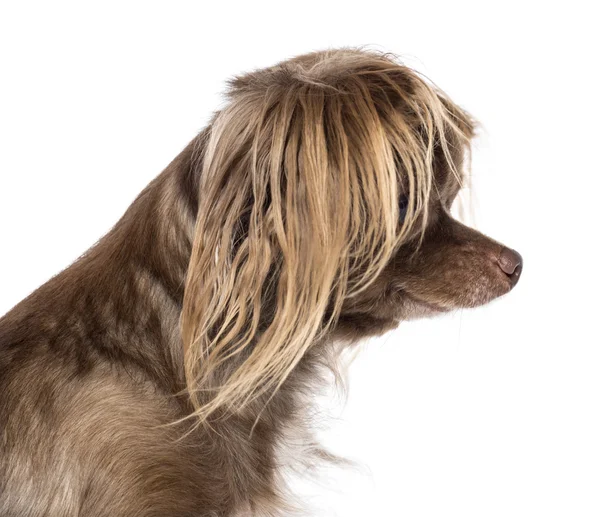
(0, 0), (600, 517)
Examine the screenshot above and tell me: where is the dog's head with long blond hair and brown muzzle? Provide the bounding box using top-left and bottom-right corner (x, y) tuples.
(182, 50), (522, 416)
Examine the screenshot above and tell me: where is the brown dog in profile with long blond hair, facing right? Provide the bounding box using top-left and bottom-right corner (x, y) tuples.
(0, 48), (523, 517)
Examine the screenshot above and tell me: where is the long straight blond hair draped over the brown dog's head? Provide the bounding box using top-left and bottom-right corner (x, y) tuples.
(182, 52), (468, 419)
